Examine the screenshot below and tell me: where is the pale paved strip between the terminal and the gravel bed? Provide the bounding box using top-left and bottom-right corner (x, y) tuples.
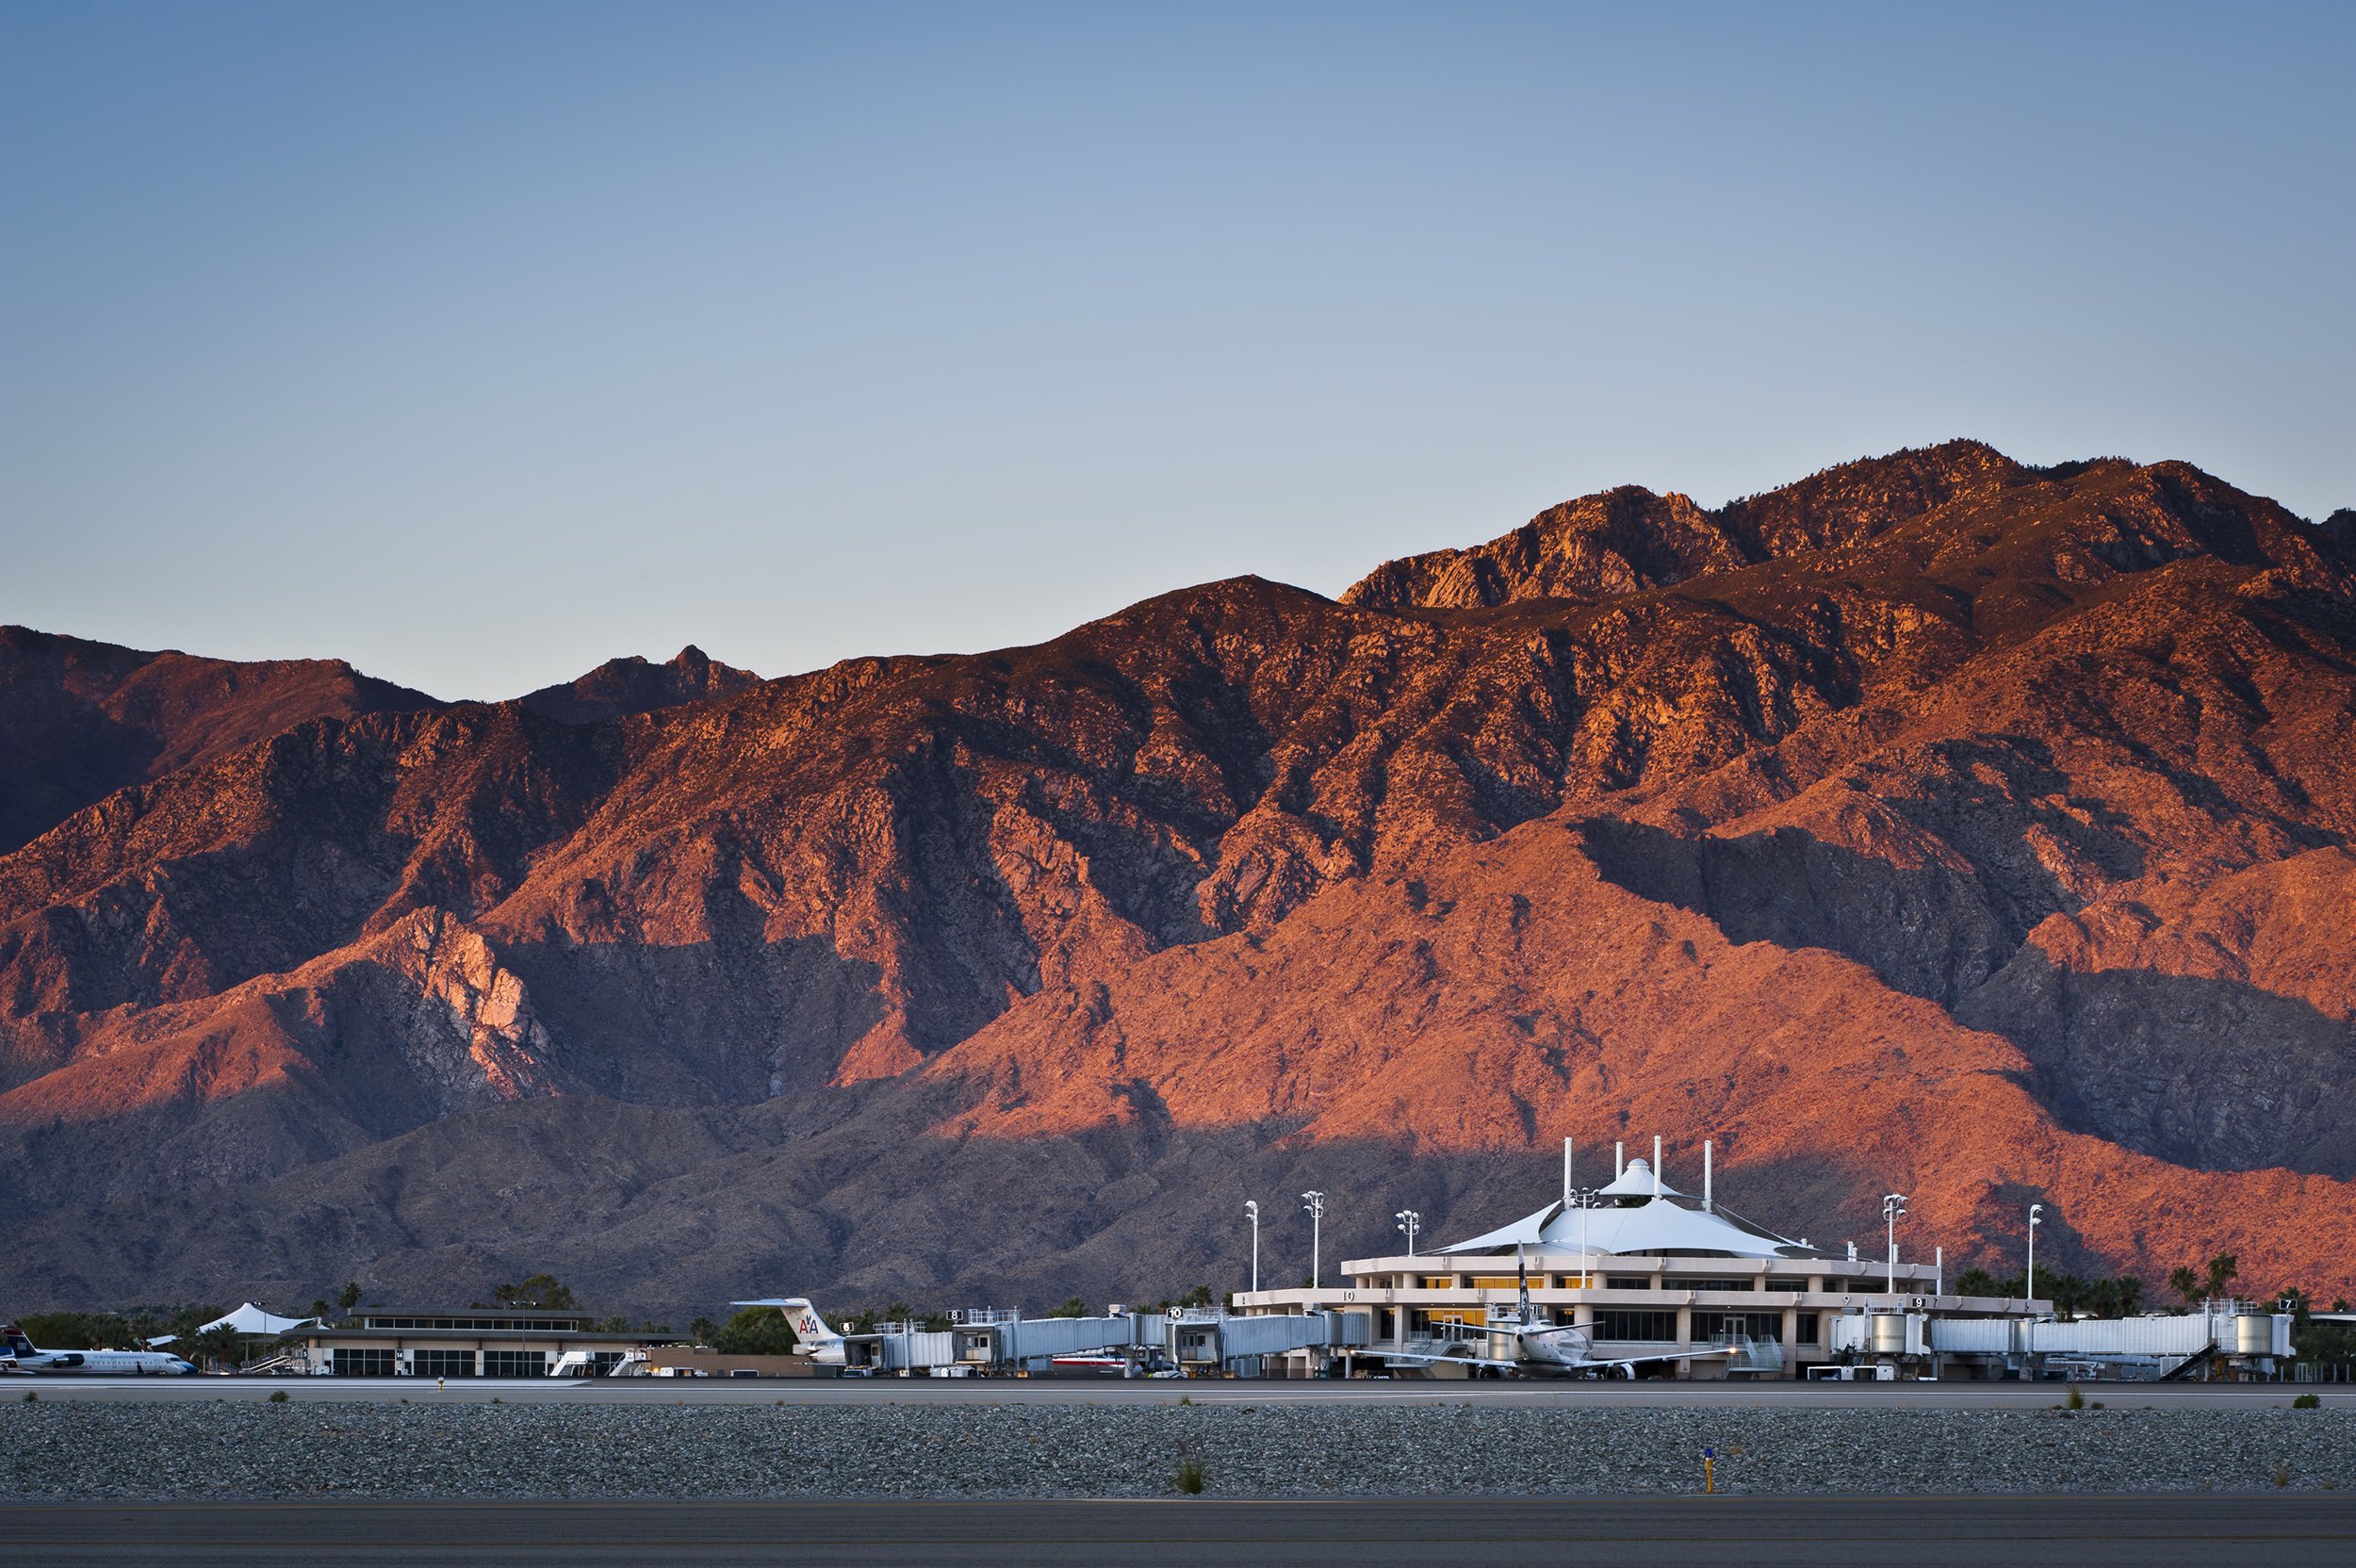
(13, 1378), (2356, 1411)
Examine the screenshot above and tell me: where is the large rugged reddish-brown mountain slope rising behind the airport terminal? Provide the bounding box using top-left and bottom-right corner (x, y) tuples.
(0, 443), (2356, 1312)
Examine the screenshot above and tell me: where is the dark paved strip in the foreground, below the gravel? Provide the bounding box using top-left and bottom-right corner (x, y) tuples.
(0, 1493), (2356, 1568)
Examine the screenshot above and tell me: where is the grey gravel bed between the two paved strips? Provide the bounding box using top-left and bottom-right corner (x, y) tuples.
(0, 1401), (2356, 1502)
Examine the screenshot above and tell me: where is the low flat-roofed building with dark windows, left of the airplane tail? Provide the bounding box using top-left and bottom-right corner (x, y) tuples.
(283, 1307), (650, 1378)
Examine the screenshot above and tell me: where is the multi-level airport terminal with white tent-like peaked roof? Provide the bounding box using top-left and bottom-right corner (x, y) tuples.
(1235, 1158), (2053, 1378)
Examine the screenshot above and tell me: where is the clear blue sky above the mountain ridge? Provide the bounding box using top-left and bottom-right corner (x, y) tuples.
(0, 0), (2356, 697)
